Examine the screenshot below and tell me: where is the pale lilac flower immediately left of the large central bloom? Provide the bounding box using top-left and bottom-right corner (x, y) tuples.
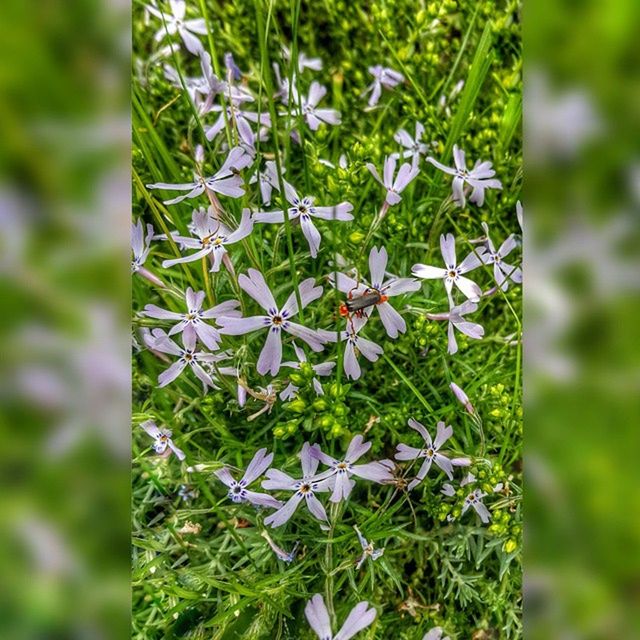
(142, 287), (241, 351)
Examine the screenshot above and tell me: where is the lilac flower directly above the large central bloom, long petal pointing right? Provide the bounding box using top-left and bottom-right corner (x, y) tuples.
(253, 185), (353, 258)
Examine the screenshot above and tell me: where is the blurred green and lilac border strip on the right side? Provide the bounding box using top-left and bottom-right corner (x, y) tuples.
(524, 0), (640, 639)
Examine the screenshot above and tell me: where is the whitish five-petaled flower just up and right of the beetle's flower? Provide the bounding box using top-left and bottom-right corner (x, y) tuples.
(411, 233), (485, 307)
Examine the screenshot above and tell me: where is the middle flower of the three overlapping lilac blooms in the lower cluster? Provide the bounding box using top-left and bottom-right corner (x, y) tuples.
(262, 442), (331, 529)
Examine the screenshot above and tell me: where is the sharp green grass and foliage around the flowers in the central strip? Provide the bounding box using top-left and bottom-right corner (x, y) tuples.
(132, 0), (522, 640)
